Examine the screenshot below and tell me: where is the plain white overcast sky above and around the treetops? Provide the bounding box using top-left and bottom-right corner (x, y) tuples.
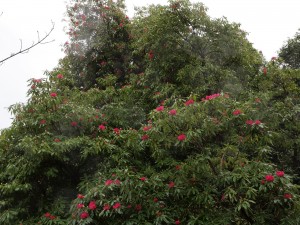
(0, 0), (300, 130)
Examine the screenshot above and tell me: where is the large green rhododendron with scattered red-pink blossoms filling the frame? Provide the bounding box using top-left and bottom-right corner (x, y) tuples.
(0, 0), (300, 225)
